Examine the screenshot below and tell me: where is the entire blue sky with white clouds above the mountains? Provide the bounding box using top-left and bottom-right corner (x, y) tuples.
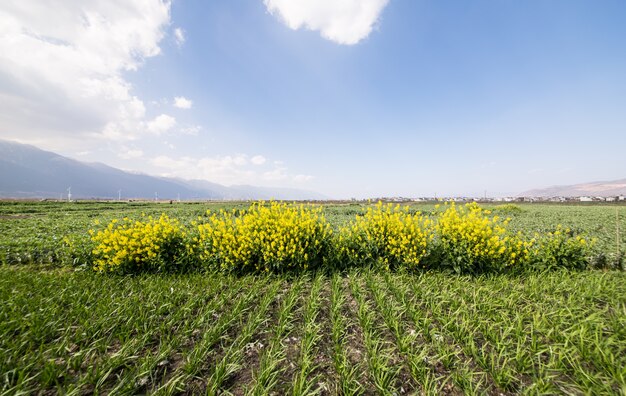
(0, 0), (626, 198)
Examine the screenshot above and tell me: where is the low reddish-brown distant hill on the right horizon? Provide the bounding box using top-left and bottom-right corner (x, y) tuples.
(519, 179), (626, 197)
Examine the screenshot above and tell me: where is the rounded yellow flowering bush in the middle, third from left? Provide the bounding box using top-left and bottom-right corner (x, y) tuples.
(338, 202), (433, 270)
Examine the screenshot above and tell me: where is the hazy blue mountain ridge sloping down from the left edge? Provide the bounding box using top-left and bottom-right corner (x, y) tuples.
(0, 140), (328, 200)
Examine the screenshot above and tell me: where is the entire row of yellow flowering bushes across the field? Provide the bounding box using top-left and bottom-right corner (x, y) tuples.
(84, 202), (592, 273)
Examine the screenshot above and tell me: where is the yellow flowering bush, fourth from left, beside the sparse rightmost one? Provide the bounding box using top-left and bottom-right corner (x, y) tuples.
(435, 202), (532, 273)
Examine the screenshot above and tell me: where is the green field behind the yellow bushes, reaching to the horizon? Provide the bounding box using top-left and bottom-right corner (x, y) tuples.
(0, 201), (626, 264)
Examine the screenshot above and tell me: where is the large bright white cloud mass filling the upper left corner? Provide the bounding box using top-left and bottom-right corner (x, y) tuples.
(0, 0), (170, 146)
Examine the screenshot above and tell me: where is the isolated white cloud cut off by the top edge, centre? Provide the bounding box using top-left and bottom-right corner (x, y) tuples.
(263, 0), (389, 45)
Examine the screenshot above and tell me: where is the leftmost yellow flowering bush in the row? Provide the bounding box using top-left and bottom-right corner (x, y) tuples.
(90, 214), (191, 273)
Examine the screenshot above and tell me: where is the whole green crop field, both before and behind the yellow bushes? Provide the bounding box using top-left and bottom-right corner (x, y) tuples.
(0, 202), (626, 395)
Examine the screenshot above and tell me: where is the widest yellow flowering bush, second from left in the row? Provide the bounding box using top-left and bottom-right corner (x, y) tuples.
(195, 201), (332, 272)
